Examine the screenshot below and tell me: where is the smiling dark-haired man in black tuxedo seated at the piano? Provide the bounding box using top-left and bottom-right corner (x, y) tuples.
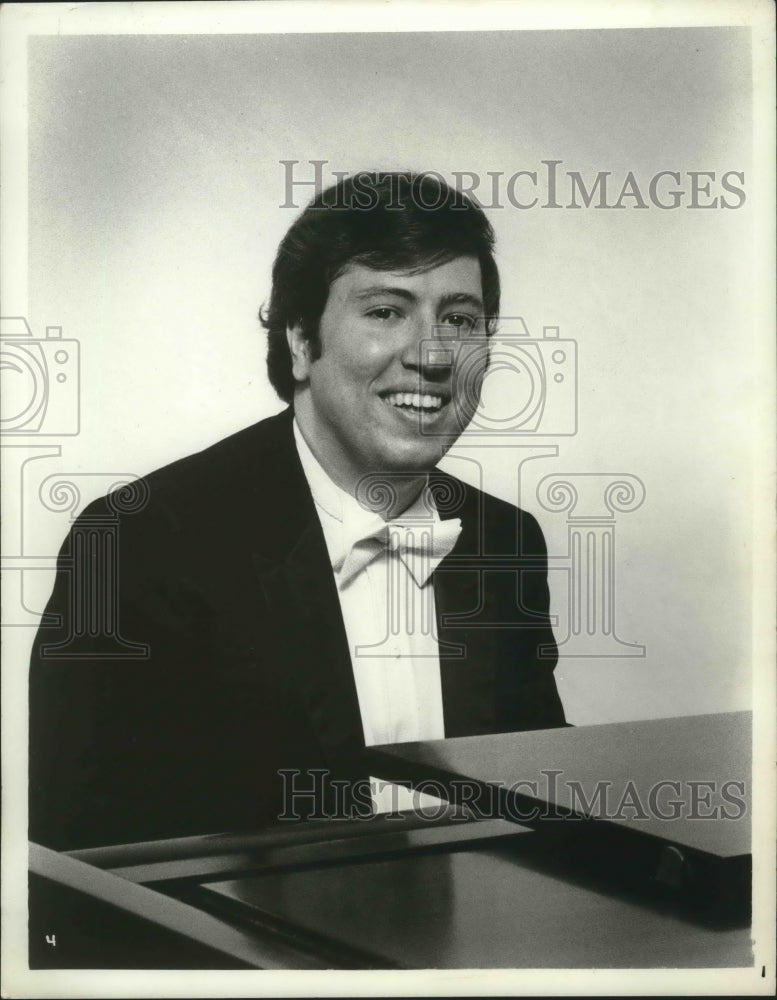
(30, 174), (564, 848)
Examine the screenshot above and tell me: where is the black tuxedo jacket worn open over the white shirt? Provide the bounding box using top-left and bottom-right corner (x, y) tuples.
(30, 410), (565, 849)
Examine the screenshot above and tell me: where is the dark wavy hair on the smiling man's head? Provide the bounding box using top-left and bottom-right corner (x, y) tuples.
(259, 171), (500, 403)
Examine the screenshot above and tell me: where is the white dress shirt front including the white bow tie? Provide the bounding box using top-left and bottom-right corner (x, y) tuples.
(294, 420), (461, 812)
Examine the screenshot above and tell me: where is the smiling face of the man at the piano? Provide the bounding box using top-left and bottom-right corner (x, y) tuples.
(289, 257), (488, 488)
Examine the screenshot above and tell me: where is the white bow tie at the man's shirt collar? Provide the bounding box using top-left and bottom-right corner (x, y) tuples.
(332, 514), (461, 587)
